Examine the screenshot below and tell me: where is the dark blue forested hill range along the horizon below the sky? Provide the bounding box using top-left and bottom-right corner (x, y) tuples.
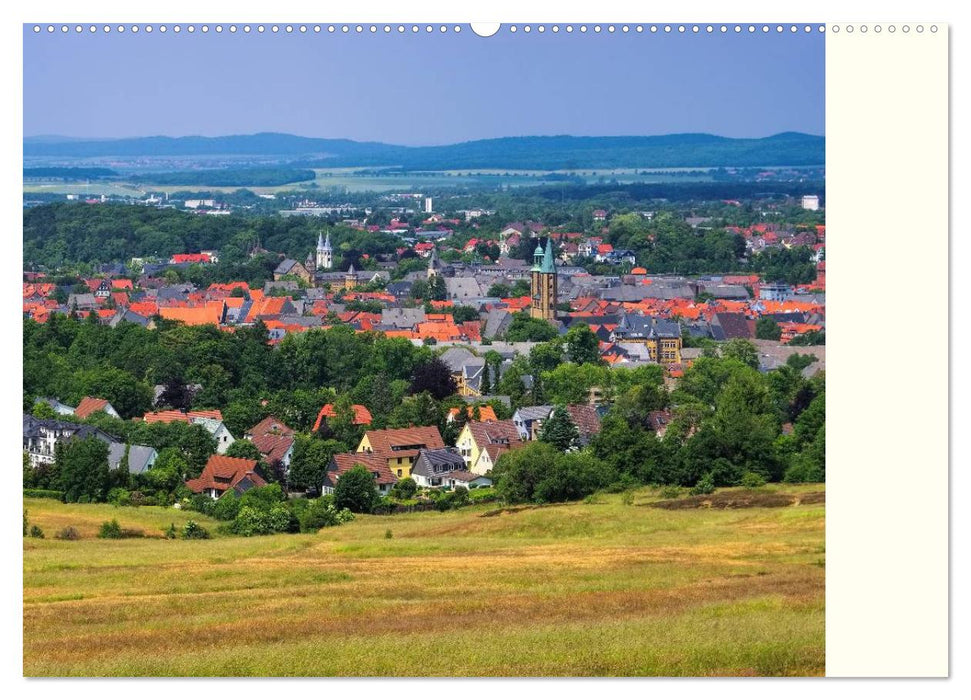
(23, 132), (825, 170)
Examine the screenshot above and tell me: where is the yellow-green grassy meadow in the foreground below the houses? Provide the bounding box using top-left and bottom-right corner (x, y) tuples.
(24, 485), (825, 676)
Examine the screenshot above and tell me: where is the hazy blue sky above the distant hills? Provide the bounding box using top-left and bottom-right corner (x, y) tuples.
(24, 26), (824, 145)
